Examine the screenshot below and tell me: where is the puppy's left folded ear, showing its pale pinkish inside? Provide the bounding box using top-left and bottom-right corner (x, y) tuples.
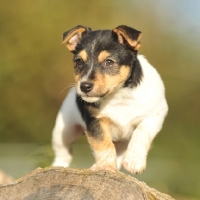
(62, 25), (91, 52)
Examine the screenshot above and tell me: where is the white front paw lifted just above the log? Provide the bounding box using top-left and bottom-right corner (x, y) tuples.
(122, 154), (146, 174)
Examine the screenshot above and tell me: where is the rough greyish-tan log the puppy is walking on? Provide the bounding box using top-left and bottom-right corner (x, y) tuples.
(0, 167), (173, 200)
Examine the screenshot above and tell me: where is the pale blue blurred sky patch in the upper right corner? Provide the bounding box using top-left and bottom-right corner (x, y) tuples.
(155, 0), (200, 44)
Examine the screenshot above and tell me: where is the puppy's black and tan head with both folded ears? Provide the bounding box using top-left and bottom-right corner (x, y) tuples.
(62, 25), (142, 103)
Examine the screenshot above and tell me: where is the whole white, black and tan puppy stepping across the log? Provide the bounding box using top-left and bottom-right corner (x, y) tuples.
(52, 25), (168, 173)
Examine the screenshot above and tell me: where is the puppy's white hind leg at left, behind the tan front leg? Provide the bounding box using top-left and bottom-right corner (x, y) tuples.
(52, 90), (85, 167)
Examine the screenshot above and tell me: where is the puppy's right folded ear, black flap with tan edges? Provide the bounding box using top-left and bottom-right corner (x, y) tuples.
(113, 25), (142, 50)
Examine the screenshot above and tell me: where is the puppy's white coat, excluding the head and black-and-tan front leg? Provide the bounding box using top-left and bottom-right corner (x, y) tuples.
(52, 56), (168, 173)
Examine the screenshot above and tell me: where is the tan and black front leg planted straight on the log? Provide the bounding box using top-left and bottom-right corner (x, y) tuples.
(86, 119), (117, 172)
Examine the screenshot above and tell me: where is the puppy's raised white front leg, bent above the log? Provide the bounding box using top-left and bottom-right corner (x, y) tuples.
(122, 114), (165, 174)
